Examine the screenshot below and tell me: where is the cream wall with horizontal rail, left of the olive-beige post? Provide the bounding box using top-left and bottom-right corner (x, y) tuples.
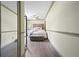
(1, 6), (17, 47)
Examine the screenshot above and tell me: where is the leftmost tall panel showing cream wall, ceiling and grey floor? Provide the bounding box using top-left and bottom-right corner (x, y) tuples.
(0, 1), (17, 57)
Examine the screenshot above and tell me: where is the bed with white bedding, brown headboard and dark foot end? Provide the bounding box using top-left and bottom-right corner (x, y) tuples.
(29, 24), (48, 41)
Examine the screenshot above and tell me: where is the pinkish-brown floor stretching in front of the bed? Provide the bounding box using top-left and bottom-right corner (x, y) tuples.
(25, 37), (60, 57)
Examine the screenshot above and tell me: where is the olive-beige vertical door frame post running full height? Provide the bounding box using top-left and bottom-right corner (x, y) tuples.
(17, 1), (25, 57)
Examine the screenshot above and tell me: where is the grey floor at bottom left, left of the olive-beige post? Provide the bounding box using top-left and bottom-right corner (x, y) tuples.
(1, 42), (17, 57)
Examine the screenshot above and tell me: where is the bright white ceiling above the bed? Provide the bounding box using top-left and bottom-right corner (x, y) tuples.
(25, 1), (51, 19)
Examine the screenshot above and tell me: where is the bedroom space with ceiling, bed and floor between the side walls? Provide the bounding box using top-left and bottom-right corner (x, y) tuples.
(25, 1), (60, 57)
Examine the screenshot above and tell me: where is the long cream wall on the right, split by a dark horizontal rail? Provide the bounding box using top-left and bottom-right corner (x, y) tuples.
(46, 1), (79, 56)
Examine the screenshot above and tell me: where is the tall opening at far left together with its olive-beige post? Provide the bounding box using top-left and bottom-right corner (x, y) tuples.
(0, 1), (25, 57)
